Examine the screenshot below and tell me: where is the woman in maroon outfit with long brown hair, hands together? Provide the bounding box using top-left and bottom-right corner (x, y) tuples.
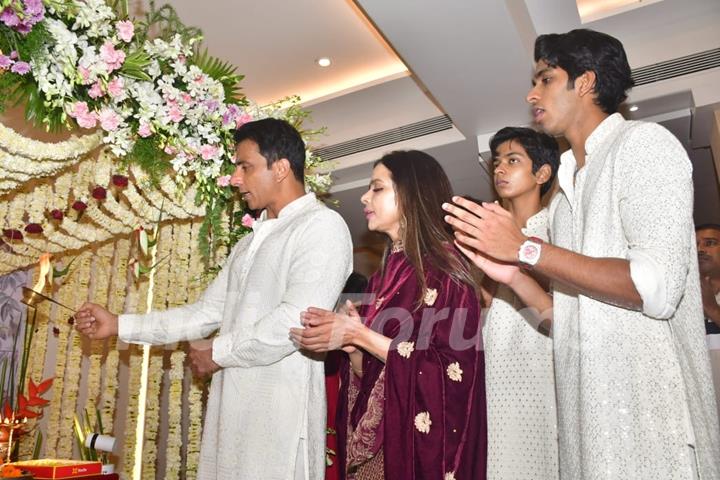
(291, 151), (487, 480)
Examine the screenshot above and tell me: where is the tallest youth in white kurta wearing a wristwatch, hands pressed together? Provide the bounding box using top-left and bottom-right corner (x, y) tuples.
(448, 30), (720, 480)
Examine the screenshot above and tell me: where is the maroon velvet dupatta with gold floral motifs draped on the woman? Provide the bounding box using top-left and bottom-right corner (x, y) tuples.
(337, 252), (487, 480)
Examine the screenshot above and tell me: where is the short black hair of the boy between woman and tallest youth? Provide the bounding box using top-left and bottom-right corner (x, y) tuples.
(490, 127), (560, 196)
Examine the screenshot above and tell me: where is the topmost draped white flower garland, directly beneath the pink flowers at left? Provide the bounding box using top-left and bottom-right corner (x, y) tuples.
(0, 123), (102, 162)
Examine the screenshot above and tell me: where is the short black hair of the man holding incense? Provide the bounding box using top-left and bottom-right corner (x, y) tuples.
(234, 118), (305, 184)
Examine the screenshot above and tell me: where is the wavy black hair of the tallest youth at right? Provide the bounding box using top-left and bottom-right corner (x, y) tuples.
(535, 29), (635, 114)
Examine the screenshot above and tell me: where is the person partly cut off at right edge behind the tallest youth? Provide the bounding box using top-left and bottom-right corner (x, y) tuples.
(695, 223), (720, 412)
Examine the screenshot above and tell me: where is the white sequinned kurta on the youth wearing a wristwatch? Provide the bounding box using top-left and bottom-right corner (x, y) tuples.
(550, 114), (720, 480)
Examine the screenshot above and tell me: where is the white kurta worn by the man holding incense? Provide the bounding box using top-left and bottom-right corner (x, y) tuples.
(119, 194), (352, 480)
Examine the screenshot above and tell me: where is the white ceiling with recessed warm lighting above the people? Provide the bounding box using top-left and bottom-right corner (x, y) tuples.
(158, 0), (720, 246)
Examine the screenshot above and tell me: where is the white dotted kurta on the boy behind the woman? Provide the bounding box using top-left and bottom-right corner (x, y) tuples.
(483, 209), (558, 480)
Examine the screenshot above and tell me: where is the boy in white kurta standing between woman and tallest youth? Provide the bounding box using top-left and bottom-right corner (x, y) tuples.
(483, 127), (560, 480)
